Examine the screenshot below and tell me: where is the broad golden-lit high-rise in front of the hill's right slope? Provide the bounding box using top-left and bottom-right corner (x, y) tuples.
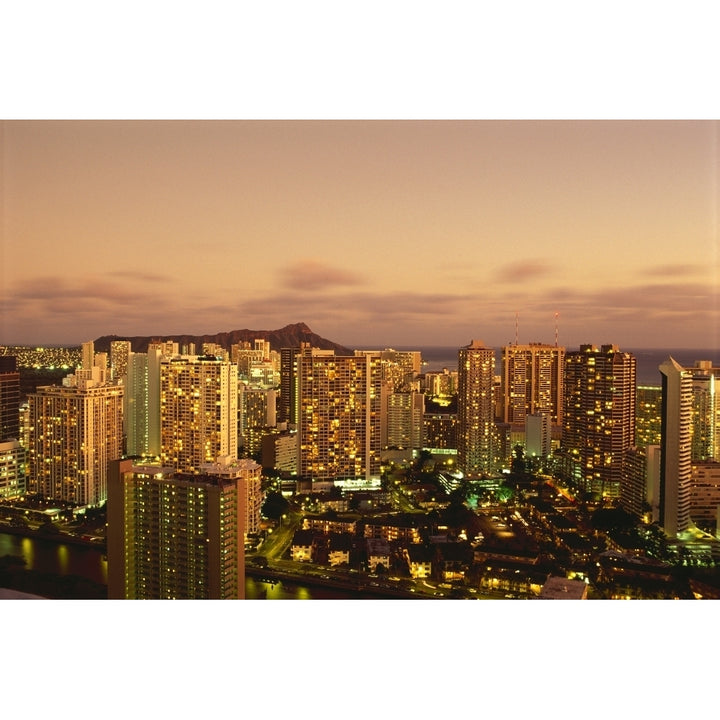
(297, 347), (382, 481)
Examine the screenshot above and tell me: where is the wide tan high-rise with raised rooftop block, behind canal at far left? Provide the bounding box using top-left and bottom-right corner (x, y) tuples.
(28, 368), (123, 506)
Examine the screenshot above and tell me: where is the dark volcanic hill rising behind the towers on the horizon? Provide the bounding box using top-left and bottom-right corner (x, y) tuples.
(95, 323), (353, 355)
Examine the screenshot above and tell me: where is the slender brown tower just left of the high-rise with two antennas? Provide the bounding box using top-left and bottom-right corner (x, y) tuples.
(457, 340), (495, 477)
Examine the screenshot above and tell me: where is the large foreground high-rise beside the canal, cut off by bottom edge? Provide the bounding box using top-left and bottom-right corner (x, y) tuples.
(107, 460), (247, 599)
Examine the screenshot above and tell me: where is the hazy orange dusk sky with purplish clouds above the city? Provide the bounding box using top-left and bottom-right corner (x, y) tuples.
(0, 120), (720, 348)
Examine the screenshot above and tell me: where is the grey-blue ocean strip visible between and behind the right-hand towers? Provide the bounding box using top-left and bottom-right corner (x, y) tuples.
(404, 345), (720, 385)
